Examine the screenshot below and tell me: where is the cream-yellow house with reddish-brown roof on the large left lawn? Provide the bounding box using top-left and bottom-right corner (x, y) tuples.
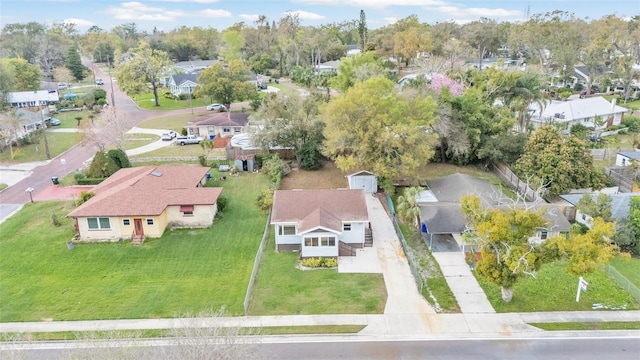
(67, 165), (222, 243)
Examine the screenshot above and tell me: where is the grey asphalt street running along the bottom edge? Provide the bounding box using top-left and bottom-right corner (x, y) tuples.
(0, 335), (640, 360)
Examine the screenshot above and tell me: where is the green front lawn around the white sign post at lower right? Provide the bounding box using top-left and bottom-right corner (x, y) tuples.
(474, 262), (638, 313)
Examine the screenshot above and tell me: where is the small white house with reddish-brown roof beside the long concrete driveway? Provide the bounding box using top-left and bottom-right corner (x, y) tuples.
(271, 189), (372, 258)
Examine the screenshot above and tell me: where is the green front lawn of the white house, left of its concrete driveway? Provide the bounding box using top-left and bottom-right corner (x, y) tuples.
(249, 234), (387, 315)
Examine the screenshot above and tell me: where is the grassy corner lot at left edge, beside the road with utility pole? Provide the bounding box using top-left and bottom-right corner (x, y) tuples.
(0, 131), (81, 164)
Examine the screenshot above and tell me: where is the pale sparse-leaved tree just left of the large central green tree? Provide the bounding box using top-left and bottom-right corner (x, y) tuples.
(251, 93), (324, 169)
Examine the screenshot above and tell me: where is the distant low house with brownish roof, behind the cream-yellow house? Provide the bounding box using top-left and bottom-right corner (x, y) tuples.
(186, 111), (249, 141)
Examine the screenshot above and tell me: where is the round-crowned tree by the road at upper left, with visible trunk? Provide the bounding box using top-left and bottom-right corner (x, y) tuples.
(116, 41), (172, 106)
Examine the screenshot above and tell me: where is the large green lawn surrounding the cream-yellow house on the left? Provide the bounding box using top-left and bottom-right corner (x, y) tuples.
(0, 171), (268, 322)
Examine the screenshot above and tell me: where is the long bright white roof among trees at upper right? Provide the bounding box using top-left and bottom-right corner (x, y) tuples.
(532, 96), (629, 121)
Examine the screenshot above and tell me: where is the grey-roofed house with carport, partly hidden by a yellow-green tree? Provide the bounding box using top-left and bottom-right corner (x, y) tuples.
(416, 173), (570, 247)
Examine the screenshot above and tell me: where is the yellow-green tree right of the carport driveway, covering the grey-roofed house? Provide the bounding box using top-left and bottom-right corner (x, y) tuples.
(461, 195), (547, 302)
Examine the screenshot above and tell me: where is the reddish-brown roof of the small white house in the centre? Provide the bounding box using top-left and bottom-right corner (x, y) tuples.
(271, 189), (369, 228)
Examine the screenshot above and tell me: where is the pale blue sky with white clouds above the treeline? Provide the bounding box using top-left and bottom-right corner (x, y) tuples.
(0, 0), (640, 32)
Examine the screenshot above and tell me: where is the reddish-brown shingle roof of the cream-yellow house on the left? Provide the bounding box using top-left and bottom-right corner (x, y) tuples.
(68, 165), (222, 217)
